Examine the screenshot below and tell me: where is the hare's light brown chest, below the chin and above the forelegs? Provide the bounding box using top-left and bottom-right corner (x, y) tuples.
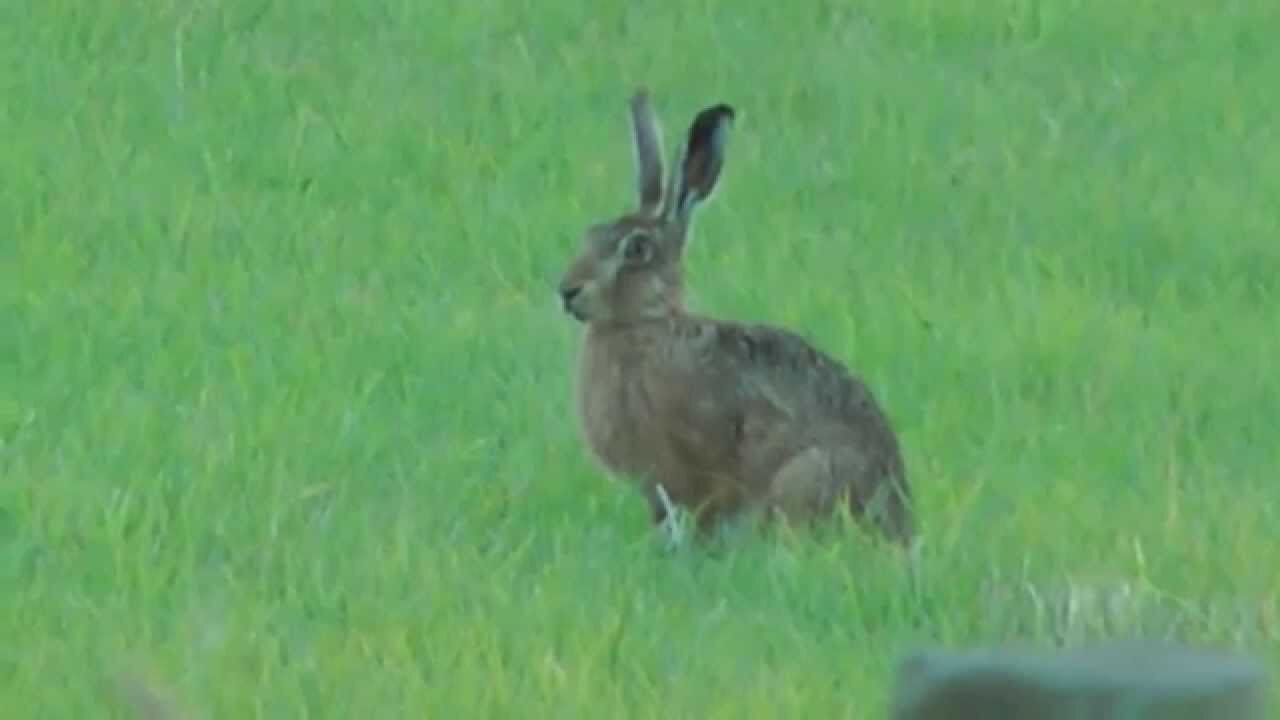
(576, 338), (664, 475)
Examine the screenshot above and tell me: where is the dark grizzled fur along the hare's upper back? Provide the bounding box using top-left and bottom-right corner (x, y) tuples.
(680, 319), (876, 415)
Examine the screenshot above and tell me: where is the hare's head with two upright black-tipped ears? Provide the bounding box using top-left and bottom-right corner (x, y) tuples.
(559, 90), (733, 324)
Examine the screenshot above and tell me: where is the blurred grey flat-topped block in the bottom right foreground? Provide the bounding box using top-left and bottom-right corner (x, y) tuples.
(890, 644), (1267, 720)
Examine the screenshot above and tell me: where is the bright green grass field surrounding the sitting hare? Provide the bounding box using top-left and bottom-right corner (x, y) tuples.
(0, 0), (1280, 719)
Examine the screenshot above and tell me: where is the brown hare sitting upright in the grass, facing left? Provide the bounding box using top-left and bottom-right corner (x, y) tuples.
(558, 88), (914, 546)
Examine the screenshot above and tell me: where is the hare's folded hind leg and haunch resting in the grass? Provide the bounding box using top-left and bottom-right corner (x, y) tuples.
(768, 445), (914, 544)
